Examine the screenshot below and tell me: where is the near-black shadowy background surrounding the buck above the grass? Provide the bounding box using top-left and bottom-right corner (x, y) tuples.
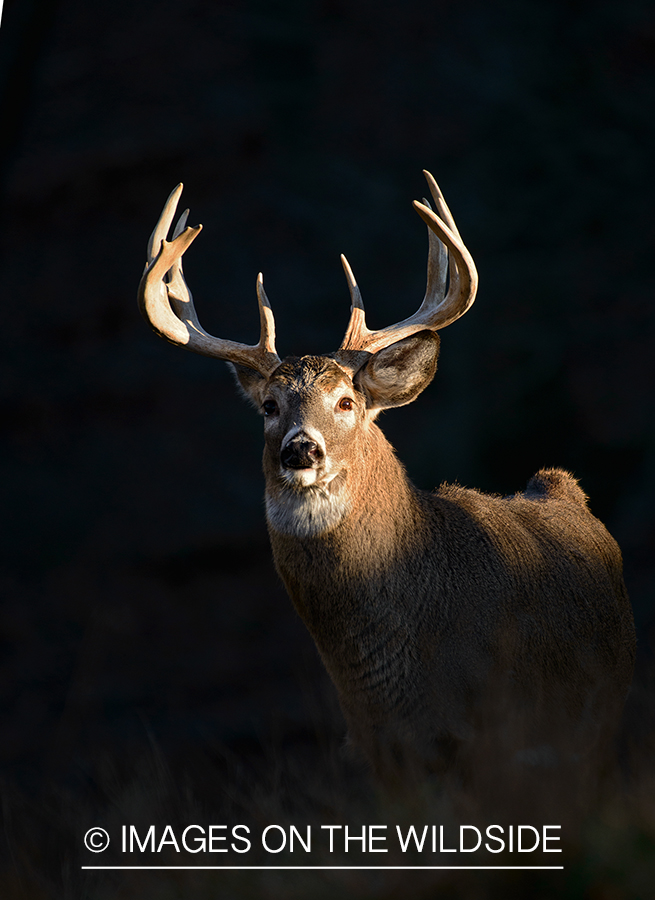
(0, 0), (655, 896)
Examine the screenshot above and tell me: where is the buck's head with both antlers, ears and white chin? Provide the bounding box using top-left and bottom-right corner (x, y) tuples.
(139, 172), (477, 535)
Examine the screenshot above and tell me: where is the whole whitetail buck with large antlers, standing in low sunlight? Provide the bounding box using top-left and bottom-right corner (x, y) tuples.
(139, 172), (635, 779)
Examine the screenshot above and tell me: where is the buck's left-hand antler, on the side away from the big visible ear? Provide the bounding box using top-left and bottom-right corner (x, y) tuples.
(139, 184), (280, 376)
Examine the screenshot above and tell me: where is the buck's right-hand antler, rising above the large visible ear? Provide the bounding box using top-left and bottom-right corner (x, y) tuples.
(339, 170), (478, 353)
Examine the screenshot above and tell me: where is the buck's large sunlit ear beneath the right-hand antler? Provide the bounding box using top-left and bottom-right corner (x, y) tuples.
(354, 331), (439, 409)
